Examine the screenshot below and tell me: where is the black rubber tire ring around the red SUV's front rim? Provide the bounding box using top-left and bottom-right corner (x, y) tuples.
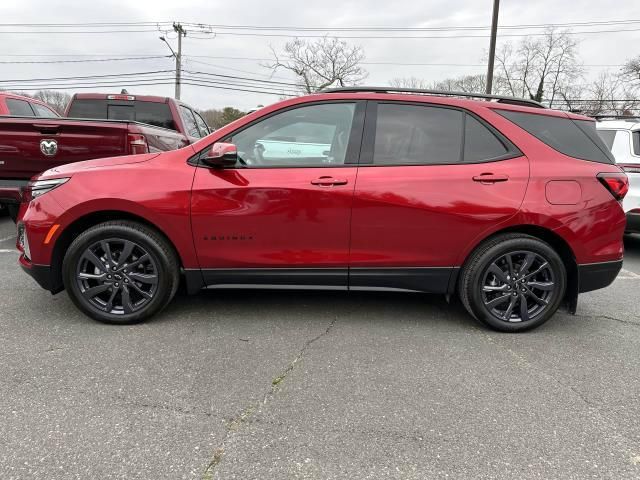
(62, 225), (172, 324)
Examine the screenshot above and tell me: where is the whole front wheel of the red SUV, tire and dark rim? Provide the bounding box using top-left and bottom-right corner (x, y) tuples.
(62, 221), (180, 325)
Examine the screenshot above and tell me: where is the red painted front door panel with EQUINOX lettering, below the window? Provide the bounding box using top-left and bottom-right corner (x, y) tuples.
(191, 165), (357, 268)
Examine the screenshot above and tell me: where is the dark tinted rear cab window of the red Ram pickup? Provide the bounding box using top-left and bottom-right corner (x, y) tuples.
(68, 98), (176, 130)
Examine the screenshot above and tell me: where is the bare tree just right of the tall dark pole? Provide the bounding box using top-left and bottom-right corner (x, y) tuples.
(496, 28), (583, 106)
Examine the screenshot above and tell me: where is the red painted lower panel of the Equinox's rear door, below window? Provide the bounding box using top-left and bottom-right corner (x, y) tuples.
(351, 157), (529, 267)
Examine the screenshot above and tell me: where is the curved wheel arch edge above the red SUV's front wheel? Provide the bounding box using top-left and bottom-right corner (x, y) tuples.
(51, 210), (184, 293)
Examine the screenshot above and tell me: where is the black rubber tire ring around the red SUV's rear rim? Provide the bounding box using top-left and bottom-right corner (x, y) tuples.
(468, 237), (567, 332)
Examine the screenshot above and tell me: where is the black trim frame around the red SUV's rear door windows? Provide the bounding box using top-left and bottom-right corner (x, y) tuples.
(358, 100), (524, 167)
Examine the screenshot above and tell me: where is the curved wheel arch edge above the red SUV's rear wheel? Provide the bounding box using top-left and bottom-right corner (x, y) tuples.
(450, 224), (579, 313)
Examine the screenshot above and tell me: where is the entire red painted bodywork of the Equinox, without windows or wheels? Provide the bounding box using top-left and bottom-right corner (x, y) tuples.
(21, 93), (625, 296)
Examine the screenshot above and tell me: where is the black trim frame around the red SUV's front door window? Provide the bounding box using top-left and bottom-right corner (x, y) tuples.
(187, 99), (367, 170)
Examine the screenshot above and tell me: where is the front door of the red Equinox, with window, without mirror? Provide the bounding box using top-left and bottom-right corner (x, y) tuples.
(191, 102), (364, 288)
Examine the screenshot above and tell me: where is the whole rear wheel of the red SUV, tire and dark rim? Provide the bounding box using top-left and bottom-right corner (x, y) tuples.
(458, 233), (567, 332)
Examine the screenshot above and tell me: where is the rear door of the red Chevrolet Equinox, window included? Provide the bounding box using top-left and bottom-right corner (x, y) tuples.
(350, 102), (529, 293)
